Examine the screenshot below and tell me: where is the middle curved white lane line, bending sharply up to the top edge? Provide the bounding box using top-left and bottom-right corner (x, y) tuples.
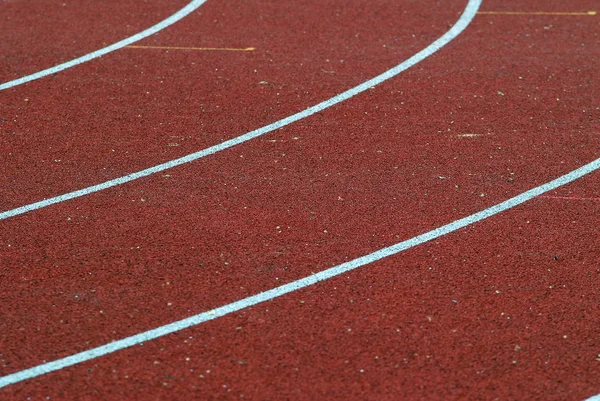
(0, 0), (481, 220)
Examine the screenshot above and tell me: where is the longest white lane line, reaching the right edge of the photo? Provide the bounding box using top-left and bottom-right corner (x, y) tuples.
(0, 155), (600, 388)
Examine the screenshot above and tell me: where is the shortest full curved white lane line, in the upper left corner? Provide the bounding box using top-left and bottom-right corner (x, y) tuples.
(0, 0), (206, 90)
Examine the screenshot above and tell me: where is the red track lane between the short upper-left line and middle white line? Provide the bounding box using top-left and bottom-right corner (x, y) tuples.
(0, 2), (458, 210)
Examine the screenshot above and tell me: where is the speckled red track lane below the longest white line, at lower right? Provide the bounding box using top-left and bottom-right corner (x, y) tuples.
(4, 172), (598, 399)
